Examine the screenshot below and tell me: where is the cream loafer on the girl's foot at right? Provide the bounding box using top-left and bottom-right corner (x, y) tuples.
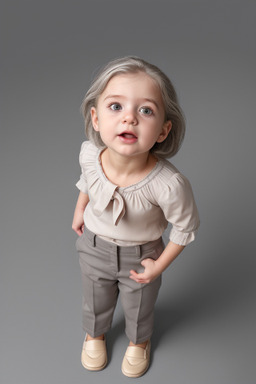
(122, 341), (151, 377)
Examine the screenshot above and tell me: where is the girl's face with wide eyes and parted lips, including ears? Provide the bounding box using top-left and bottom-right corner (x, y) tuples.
(91, 72), (171, 156)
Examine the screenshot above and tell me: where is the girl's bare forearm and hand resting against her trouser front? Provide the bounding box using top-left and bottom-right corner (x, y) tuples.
(130, 241), (185, 284)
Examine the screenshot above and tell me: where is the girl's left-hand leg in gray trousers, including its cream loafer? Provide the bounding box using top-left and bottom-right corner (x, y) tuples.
(76, 231), (118, 371)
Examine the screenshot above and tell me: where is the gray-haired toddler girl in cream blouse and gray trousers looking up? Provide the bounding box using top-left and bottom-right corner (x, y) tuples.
(72, 57), (199, 377)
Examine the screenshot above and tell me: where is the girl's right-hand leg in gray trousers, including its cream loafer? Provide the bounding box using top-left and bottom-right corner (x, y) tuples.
(119, 240), (164, 378)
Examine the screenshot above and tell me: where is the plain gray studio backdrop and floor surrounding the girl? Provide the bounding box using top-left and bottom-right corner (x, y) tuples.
(0, 0), (256, 384)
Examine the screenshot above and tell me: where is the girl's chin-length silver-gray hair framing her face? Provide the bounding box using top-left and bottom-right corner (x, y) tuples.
(81, 56), (185, 158)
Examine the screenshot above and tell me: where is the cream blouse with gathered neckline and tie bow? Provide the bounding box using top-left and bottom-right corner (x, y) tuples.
(76, 141), (199, 245)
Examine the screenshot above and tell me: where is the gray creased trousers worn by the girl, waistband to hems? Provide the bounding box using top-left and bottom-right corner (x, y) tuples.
(76, 228), (164, 344)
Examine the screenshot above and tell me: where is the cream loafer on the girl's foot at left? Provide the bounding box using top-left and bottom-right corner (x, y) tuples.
(81, 338), (108, 371)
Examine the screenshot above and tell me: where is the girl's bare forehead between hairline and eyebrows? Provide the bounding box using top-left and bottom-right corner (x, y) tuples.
(102, 72), (162, 99)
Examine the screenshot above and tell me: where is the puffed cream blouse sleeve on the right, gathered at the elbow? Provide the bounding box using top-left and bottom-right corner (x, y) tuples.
(159, 173), (200, 245)
